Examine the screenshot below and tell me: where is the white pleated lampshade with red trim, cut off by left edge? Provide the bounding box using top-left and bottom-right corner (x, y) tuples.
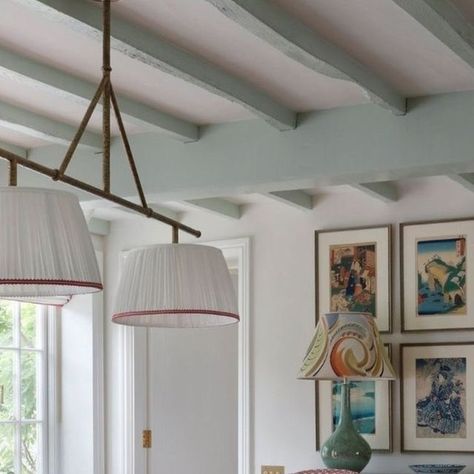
(0, 187), (102, 300)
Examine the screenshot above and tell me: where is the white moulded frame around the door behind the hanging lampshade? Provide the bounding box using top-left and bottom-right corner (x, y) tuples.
(118, 237), (251, 474)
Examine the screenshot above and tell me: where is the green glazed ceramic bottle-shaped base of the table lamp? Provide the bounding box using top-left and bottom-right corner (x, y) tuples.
(321, 381), (372, 472)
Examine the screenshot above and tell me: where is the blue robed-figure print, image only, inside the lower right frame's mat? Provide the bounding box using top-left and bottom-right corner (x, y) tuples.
(416, 357), (466, 438)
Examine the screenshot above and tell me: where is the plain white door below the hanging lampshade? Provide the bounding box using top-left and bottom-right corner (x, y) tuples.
(148, 325), (238, 474)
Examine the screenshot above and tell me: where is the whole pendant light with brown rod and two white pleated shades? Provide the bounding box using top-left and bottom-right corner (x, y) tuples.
(0, 0), (239, 327)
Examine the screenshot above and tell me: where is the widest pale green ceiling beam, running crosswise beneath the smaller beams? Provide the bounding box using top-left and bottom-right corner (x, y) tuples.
(26, 91), (474, 202)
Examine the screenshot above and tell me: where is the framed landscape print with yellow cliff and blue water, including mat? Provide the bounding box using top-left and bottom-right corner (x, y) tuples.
(400, 219), (474, 332)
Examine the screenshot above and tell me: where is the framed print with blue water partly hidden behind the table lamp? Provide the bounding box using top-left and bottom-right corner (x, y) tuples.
(316, 344), (393, 452)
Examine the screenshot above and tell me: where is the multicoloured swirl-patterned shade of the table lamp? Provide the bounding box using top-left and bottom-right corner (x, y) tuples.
(298, 313), (396, 380)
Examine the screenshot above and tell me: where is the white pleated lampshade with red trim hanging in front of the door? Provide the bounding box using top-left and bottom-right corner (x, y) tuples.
(113, 244), (239, 328)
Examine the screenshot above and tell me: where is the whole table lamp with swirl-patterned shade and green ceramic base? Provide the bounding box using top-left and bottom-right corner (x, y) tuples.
(298, 312), (395, 472)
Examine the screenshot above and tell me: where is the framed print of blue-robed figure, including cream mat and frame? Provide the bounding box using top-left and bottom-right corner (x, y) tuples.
(400, 342), (474, 452)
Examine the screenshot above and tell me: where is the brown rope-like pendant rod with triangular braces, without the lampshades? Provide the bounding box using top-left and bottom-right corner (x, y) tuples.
(0, 0), (201, 239)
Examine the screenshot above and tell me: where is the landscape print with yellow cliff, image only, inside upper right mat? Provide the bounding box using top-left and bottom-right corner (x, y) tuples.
(417, 236), (466, 316)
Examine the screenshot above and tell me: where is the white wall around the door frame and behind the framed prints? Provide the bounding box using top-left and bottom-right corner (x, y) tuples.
(106, 178), (474, 474)
